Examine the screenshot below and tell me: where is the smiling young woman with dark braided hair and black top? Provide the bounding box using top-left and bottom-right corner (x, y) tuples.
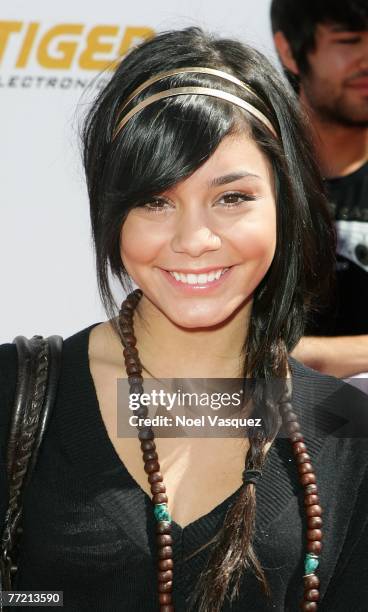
(0, 29), (368, 612)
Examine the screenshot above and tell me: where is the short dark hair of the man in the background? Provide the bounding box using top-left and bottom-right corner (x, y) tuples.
(271, 0), (368, 85)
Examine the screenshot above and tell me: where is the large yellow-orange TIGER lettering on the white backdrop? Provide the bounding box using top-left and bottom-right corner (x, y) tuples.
(0, 21), (155, 70)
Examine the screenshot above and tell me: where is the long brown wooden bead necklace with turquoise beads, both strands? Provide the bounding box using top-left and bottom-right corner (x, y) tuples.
(119, 289), (322, 612)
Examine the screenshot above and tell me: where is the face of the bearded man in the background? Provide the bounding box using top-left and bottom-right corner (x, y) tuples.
(300, 24), (368, 127)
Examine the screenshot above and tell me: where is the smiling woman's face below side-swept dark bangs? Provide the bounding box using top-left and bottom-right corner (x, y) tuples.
(121, 134), (276, 328)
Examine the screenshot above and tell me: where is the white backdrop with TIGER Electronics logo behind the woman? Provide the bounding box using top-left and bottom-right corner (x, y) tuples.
(0, 0), (275, 342)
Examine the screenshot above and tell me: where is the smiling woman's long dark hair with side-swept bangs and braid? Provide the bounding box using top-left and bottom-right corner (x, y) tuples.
(83, 28), (334, 612)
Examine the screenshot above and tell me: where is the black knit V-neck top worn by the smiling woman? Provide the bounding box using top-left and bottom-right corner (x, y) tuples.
(0, 324), (368, 612)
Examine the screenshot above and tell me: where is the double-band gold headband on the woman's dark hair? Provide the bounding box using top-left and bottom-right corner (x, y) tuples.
(112, 66), (277, 140)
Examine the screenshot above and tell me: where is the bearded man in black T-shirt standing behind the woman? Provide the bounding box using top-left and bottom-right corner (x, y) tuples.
(271, 0), (368, 377)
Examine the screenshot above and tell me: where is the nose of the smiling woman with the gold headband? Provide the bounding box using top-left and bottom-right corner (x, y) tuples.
(171, 210), (221, 257)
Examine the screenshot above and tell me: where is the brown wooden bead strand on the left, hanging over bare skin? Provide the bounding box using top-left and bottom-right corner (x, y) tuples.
(119, 289), (174, 612)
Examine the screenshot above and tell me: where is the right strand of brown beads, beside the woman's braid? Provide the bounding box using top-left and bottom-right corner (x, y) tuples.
(280, 390), (322, 612)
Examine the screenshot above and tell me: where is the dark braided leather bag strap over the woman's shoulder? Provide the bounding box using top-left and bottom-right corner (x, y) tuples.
(0, 336), (62, 596)
